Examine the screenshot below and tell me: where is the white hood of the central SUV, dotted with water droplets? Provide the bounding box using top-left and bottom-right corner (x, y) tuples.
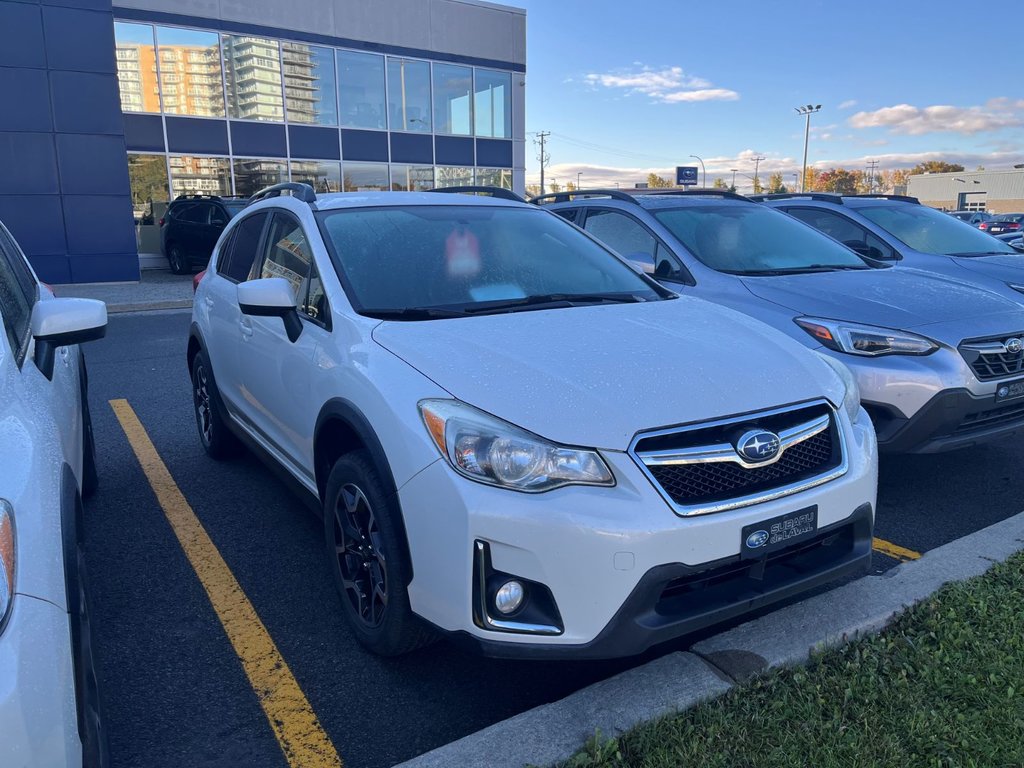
(373, 297), (843, 451)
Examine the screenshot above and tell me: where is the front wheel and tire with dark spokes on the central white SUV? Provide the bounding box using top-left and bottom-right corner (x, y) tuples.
(324, 451), (434, 656)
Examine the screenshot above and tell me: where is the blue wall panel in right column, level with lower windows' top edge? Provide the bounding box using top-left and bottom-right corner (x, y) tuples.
(56, 133), (131, 196)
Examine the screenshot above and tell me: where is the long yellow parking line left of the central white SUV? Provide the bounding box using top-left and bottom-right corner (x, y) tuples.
(110, 399), (342, 768)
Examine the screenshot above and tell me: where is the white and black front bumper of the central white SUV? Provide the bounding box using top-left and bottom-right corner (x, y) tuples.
(399, 412), (878, 658)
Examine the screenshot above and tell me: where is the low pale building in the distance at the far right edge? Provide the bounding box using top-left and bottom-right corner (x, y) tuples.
(906, 168), (1024, 213)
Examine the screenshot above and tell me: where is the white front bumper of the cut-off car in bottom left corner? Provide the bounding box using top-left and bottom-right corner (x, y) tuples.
(0, 595), (82, 768)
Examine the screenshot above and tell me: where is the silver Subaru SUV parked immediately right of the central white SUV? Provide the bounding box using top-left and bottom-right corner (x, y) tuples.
(534, 189), (1024, 453)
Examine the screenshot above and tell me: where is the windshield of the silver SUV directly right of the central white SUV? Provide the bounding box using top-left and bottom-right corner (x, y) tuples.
(653, 203), (869, 274)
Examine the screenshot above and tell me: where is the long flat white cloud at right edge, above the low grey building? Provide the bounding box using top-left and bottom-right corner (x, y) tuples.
(849, 97), (1024, 136)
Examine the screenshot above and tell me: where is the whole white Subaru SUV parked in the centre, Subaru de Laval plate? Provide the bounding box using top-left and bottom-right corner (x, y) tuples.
(187, 183), (877, 658)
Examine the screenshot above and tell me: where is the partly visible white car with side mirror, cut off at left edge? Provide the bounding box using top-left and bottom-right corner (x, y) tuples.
(0, 219), (106, 768)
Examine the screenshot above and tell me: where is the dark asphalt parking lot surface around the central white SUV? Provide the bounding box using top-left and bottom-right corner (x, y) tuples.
(86, 312), (1024, 768)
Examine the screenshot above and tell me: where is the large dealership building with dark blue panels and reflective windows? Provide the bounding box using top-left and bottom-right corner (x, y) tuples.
(0, 0), (526, 284)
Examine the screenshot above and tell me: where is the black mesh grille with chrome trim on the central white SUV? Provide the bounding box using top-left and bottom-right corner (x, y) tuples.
(631, 401), (847, 515)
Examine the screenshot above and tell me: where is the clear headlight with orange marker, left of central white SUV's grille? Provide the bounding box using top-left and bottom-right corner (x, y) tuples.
(420, 400), (614, 493)
